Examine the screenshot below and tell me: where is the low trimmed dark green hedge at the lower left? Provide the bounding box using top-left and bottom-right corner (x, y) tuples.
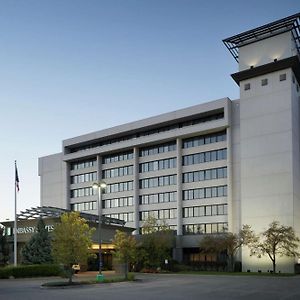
(0, 264), (61, 279)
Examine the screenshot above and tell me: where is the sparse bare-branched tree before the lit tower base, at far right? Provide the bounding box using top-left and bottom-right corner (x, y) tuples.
(250, 221), (300, 274)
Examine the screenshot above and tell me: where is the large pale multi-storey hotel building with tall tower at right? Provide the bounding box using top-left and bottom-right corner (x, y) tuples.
(39, 14), (300, 272)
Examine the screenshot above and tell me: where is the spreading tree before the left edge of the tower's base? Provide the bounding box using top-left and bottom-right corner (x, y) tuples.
(199, 225), (257, 272)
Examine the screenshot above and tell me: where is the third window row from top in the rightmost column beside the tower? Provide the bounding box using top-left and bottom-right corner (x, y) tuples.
(182, 167), (227, 183)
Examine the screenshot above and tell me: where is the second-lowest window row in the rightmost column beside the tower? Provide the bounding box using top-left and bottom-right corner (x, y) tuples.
(182, 204), (227, 218)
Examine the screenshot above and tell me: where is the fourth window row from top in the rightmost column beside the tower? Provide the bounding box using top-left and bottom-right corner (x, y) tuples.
(182, 185), (227, 200)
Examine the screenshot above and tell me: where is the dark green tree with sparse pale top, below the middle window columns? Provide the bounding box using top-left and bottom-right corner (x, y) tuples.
(139, 216), (174, 269)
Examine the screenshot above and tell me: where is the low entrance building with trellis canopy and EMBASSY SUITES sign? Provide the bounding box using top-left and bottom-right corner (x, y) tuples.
(0, 206), (134, 271)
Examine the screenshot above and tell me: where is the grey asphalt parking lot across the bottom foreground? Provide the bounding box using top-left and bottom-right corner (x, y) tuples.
(0, 274), (300, 300)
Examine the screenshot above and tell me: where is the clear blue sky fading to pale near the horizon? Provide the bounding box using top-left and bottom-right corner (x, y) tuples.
(0, 0), (300, 221)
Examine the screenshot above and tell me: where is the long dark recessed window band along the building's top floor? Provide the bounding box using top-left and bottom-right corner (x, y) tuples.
(68, 111), (224, 153)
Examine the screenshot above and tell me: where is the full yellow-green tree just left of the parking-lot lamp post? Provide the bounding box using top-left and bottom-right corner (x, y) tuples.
(52, 212), (95, 283)
